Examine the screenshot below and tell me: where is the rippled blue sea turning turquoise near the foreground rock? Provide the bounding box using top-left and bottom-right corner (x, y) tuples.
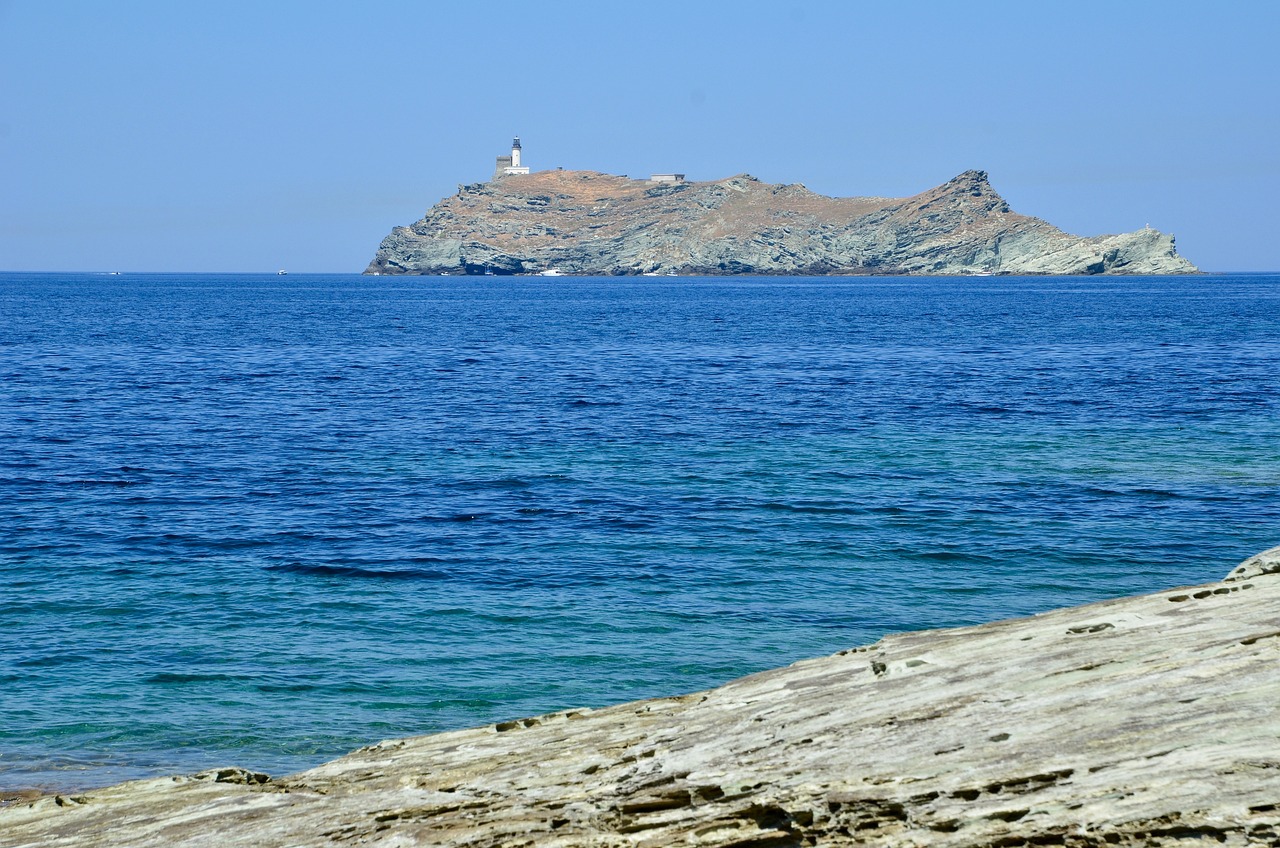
(0, 274), (1280, 788)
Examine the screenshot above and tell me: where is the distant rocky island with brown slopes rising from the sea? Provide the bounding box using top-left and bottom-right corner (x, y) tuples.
(365, 170), (1197, 274)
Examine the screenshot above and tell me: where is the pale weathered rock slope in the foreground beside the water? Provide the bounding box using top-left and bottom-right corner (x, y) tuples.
(0, 548), (1280, 848)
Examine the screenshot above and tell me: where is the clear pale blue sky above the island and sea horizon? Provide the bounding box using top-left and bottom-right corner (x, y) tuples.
(0, 0), (1280, 272)
